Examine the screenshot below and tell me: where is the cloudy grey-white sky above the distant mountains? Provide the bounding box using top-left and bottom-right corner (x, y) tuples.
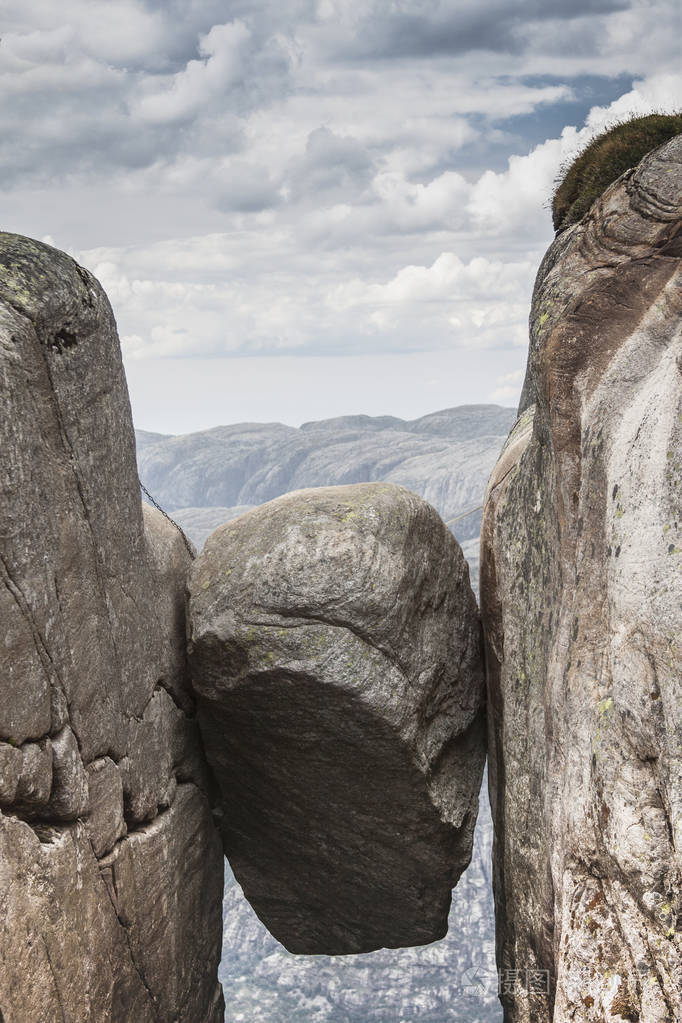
(0, 0), (682, 433)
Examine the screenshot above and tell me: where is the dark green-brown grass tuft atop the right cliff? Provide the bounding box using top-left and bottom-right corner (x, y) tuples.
(552, 114), (682, 231)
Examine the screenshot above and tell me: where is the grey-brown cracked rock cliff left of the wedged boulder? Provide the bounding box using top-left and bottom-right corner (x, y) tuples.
(0, 234), (223, 1023)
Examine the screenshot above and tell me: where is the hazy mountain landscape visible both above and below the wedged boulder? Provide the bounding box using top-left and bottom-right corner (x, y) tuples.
(137, 405), (516, 1023)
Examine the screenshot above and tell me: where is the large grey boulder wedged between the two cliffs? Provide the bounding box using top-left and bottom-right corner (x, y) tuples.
(190, 484), (485, 954)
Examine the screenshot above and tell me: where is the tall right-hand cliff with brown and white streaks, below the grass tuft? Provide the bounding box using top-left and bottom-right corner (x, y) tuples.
(481, 138), (682, 1023)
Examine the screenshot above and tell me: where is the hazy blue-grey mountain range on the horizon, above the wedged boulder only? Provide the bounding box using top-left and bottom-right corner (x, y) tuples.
(137, 405), (515, 546)
